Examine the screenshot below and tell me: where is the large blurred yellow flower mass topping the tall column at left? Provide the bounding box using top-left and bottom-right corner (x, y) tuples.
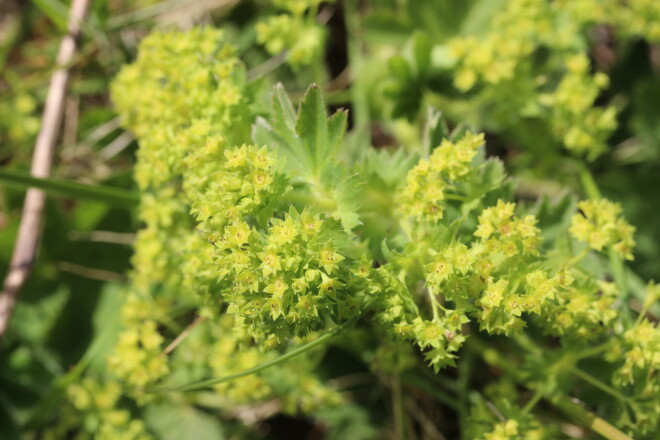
(112, 28), (249, 189)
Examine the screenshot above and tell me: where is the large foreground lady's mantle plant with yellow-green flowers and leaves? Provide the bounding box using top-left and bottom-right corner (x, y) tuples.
(51, 23), (660, 440)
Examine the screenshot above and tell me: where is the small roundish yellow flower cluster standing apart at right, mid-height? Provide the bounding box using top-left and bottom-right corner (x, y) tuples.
(570, 199), (635, 260)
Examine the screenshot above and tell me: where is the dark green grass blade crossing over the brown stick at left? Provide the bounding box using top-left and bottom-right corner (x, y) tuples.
(0, 168), (140, 208)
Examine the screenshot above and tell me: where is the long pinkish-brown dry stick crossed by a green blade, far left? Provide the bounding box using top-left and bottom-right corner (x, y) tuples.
(0, 0), (90, 337)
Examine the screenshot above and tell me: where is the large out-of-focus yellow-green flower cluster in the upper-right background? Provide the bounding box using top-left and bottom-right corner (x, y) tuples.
(450, 0), (624, 159)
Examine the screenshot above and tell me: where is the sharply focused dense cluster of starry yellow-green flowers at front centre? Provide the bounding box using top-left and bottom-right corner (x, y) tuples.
(216, 209), (358, 340)
